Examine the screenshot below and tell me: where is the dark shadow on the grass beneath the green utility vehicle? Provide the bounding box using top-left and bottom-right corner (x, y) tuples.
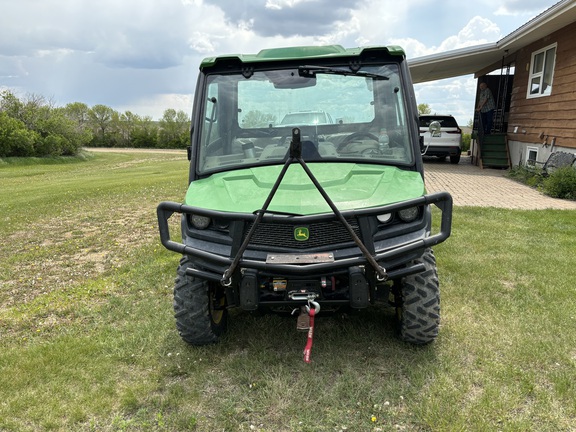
(158, 305), (435, 373)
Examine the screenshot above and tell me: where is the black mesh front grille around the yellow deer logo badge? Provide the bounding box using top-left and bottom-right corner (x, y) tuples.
(244, 218), (361, 250)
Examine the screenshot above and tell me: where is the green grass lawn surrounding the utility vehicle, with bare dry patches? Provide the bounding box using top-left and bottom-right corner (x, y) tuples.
(0, 153), (576, 431)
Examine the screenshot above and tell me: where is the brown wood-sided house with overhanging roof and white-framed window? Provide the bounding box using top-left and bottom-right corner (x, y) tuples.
(409, 0), (576, 167)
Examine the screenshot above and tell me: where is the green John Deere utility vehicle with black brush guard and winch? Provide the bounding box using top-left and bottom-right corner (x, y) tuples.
(158, 45), (452, 345)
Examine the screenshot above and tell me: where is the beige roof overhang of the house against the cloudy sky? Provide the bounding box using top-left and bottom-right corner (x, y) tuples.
(408, 0), (576, 83)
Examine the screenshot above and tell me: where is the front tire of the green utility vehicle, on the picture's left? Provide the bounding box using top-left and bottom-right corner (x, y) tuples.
(174, 256), (228, 345)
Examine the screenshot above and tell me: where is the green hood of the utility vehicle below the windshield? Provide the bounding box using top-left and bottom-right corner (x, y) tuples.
(185, 163), (425, 215)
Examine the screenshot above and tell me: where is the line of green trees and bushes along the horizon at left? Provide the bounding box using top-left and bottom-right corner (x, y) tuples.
(0, 90), (190, 158)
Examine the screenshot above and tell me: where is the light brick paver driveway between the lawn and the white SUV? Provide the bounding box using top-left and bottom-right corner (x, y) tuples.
(424, 157), (576, 210)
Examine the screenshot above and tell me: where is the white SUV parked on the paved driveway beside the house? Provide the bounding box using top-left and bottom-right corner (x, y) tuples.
(420, 115), (462, 164)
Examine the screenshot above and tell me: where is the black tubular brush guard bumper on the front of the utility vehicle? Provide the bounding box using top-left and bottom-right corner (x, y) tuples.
(157, 192), (452, 282)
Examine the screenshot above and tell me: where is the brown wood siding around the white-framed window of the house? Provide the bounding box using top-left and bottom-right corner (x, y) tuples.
(508, 23), (576, 148)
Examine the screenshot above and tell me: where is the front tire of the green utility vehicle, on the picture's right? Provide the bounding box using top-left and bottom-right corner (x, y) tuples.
(396, 249), (440, 345)
